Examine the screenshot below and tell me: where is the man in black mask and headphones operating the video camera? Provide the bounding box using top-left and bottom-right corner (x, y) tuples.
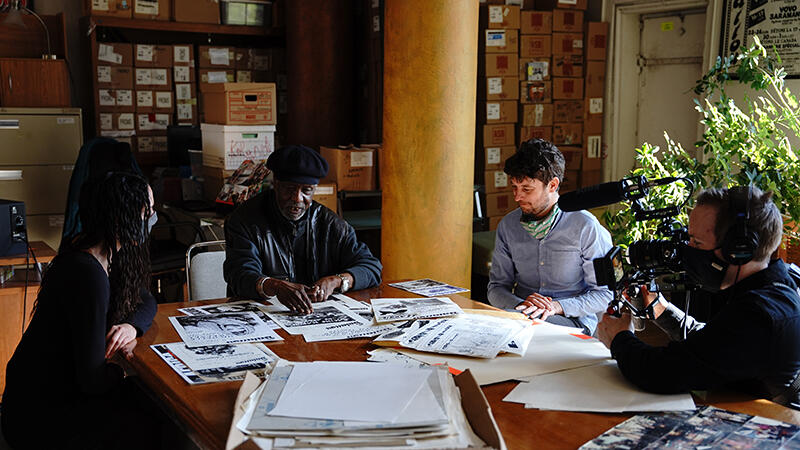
(597, 187), (800, 409)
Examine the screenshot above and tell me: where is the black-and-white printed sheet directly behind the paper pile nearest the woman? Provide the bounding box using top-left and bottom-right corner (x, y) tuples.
(169, 311), (283, 347)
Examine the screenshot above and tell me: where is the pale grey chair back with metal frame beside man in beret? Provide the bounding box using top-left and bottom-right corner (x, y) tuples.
(186, 241), (228, 301)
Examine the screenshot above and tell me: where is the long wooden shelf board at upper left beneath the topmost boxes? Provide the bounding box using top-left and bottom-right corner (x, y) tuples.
(89, 16), (284, 37)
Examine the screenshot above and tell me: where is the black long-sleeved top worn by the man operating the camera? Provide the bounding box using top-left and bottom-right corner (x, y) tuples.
(611, 261), (800, 399)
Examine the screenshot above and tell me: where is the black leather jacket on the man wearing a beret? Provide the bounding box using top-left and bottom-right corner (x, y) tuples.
(223, 190), (383, 298)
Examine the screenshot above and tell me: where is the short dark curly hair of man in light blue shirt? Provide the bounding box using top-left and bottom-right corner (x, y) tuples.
(503, 139), (564, 184)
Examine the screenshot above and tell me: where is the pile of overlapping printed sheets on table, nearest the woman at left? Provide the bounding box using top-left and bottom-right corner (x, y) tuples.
(150, 342), (279, 384)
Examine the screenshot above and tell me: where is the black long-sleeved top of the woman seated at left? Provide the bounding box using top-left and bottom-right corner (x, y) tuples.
(3, 251), (156, 419)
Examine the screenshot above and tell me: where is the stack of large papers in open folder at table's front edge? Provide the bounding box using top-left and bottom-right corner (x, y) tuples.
(236, 360), (486, 448)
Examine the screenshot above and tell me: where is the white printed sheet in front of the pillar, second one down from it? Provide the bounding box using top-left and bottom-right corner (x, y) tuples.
(370, 297), (464, 323)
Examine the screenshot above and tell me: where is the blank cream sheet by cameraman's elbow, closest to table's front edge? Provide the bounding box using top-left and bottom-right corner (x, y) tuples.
(503, 361), (695, 412)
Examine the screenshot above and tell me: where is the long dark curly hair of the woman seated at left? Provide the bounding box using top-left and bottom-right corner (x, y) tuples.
(64, 172), (152, 324)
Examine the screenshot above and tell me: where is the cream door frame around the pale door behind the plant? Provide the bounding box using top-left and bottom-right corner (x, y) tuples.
(602, 0), (722, 181)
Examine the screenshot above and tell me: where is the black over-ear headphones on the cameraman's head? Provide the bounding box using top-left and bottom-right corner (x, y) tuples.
(720, 186), (758, 266)
